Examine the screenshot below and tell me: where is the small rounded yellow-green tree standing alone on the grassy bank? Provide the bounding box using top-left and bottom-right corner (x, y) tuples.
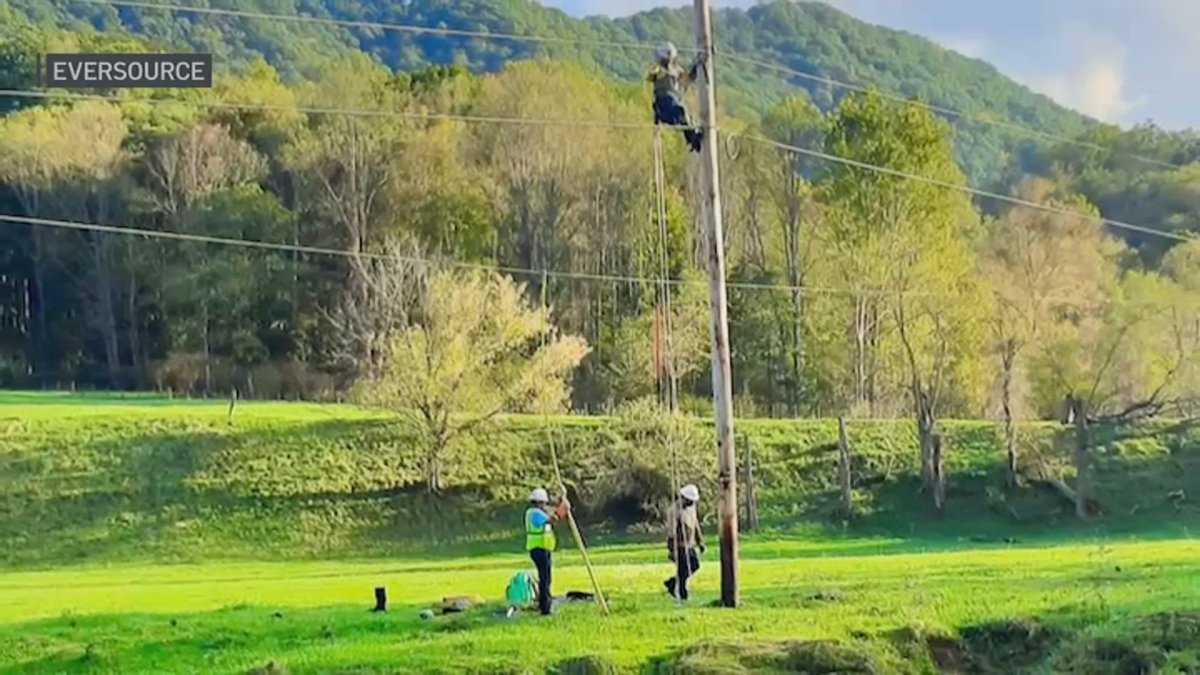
(364, 271), (588, 491)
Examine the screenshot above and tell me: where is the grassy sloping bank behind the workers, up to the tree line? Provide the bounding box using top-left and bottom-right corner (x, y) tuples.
(0, 394), (1200, 566)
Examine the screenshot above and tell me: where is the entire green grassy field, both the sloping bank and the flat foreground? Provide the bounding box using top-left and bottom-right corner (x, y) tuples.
(0, 393), (1200, 674)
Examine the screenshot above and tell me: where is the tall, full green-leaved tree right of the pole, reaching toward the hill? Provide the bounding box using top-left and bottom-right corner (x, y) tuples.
(827, 90), (985, 486)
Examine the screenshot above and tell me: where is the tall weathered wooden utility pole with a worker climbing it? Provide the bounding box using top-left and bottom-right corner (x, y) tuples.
(695, 0), (740, 607)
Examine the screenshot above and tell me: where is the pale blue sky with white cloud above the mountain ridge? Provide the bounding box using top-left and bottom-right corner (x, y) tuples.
(542, 0), (1200, 129)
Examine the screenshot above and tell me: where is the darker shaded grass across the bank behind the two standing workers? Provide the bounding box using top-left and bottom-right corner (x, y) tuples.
(0, 415), (1200, 567)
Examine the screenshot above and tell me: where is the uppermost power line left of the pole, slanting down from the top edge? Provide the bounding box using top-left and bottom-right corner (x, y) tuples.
(76, 0), (696, 52)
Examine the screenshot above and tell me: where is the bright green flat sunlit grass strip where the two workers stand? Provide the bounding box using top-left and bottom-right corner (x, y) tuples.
(0, 539), (1200, 673)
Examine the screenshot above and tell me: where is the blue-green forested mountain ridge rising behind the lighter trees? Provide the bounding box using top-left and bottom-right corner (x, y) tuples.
(8, 0), (1087, 184)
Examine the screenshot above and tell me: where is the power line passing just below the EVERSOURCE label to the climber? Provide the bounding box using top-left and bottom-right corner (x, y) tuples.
(0, 89), (683, 130)
